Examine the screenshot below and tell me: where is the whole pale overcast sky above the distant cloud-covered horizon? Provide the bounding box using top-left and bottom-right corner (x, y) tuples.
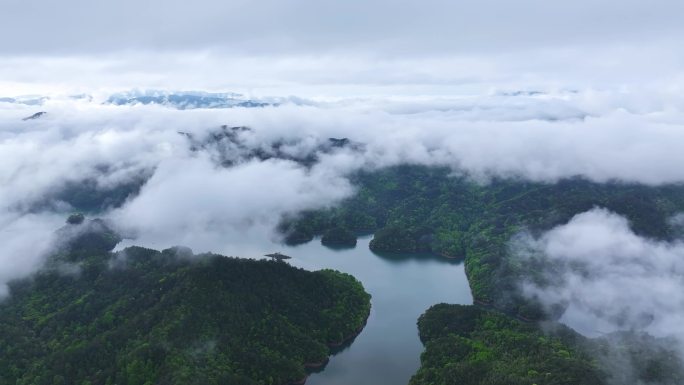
(0, 0), (684, 96)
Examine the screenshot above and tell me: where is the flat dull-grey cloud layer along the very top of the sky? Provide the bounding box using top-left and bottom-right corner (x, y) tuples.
(0, 0), (684, 55)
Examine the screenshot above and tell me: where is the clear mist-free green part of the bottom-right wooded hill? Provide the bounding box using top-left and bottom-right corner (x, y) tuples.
(410, 304), (605, 385)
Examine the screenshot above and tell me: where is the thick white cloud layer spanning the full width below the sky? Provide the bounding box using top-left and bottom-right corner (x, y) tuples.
(0, 90), (684, 294)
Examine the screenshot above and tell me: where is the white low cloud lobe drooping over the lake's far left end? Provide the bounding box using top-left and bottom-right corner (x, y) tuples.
(111, 155), (353, 251)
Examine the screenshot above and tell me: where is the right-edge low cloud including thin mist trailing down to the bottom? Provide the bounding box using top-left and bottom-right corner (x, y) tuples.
(510, 208), (684, 384)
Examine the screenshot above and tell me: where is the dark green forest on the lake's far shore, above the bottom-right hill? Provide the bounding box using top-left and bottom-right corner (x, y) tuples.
(280, 166), (684, 319)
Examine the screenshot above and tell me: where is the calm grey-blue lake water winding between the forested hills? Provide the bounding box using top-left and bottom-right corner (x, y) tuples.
(280, 236), (472, 385)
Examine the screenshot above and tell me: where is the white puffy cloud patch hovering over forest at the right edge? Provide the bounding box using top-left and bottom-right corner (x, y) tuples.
(515, 208), (684, 343)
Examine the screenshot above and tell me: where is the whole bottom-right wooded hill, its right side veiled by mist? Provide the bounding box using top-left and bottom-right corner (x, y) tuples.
(410, 304), (684, 385)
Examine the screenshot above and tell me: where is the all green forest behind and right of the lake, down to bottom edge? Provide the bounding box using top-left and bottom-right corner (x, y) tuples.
(280, 165), (684, 385)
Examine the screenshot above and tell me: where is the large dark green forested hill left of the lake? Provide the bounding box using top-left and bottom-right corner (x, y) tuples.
(0, 220), (370, 385)
